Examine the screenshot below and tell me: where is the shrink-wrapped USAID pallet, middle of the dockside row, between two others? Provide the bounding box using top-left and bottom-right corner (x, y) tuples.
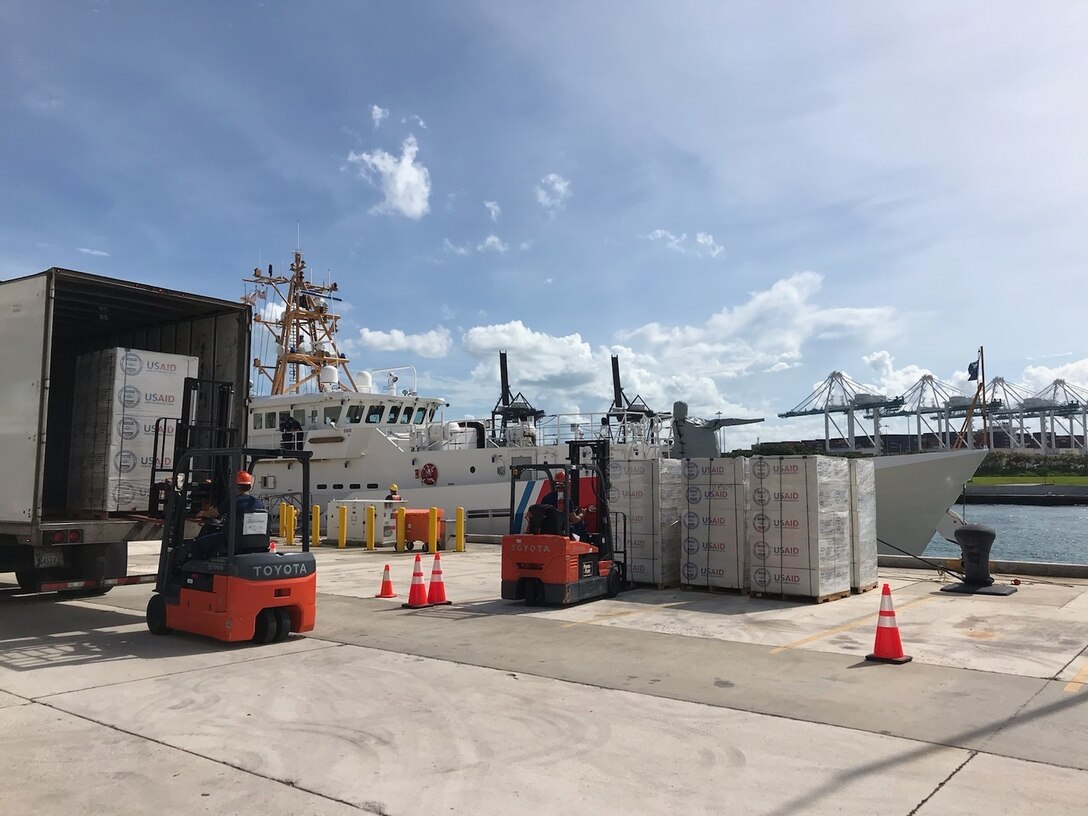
(680, 458), (749, 590)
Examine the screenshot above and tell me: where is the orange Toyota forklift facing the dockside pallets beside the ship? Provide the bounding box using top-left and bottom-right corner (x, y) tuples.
(502, 440), (627, 606)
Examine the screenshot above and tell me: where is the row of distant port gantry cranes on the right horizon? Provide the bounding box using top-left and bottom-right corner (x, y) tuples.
(778, 371), (1088, 455)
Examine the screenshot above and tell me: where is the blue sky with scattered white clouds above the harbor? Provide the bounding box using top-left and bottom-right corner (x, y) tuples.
(0, 0), (1088, 446)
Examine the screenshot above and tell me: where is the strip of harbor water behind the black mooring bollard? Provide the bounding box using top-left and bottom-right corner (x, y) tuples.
(923, 505), (1088, 564)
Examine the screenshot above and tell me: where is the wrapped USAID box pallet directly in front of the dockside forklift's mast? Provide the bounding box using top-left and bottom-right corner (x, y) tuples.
(608, 459), (683, 586)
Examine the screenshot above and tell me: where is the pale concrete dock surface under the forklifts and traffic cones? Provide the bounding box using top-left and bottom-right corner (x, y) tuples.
(0, 545), (1088, 816)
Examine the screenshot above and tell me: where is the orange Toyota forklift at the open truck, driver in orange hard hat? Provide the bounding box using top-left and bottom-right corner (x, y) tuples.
(147, 448), (317, 643)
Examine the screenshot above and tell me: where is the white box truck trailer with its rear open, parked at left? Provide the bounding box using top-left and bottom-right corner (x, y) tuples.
(0, 268), (250, 591)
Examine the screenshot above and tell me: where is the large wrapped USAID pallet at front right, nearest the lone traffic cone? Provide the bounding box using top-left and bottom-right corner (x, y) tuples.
(746, 456), (852, 598)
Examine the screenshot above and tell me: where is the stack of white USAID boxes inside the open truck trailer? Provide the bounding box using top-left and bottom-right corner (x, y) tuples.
(69, 348), (199, 514)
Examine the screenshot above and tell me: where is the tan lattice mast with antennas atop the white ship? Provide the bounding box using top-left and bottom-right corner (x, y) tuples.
(243, 249), (358, 394)
